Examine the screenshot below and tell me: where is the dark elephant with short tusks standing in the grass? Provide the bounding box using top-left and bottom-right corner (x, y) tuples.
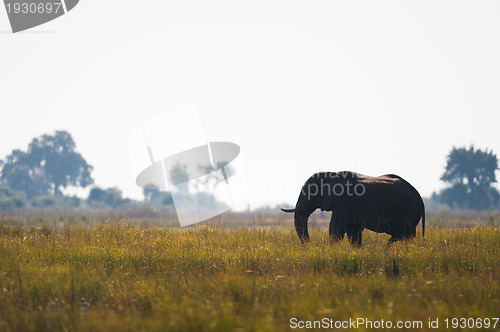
(281, 171), (425, 246)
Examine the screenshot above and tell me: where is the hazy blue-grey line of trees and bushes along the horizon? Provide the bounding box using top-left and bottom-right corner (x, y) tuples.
(0, 131), (500, 211)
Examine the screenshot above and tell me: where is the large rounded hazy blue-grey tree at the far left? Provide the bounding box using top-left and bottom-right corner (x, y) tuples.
(0, 131), (94, 199)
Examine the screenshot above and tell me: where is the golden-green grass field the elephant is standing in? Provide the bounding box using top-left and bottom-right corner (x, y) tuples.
(0, 215), (500, 331)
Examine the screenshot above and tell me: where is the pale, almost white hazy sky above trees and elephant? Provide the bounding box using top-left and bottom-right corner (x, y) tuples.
(0, 0), (500, 207)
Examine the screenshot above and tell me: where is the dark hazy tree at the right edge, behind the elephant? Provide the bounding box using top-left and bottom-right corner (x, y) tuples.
(441, 146), (500, 210)
